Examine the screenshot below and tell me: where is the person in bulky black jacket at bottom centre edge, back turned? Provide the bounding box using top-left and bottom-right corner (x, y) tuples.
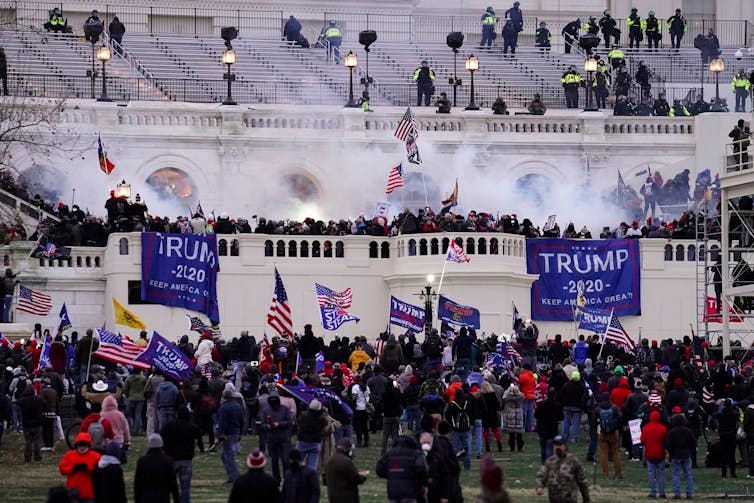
(376, 436), (427, 503)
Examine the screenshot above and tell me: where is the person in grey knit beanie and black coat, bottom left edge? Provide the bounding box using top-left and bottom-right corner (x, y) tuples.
(134, 433), (180, 503)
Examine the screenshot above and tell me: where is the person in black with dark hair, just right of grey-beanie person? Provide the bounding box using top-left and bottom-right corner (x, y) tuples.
(160, 406), (202, 503)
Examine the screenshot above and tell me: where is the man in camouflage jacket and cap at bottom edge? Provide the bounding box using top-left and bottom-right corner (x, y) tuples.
(536, 435), (590, 503)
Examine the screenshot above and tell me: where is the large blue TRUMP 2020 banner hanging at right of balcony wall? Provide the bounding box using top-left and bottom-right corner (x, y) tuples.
(526, 238), (641, 321)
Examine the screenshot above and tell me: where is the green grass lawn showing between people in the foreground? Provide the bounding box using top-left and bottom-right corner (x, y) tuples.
(0, 432), (754, 503)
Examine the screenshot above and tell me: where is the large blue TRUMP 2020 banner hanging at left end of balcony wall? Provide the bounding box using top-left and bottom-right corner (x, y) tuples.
(141, 232), (220, 324)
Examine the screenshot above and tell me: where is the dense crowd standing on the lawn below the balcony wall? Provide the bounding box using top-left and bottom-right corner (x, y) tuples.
(0, 320), (754, 503)
